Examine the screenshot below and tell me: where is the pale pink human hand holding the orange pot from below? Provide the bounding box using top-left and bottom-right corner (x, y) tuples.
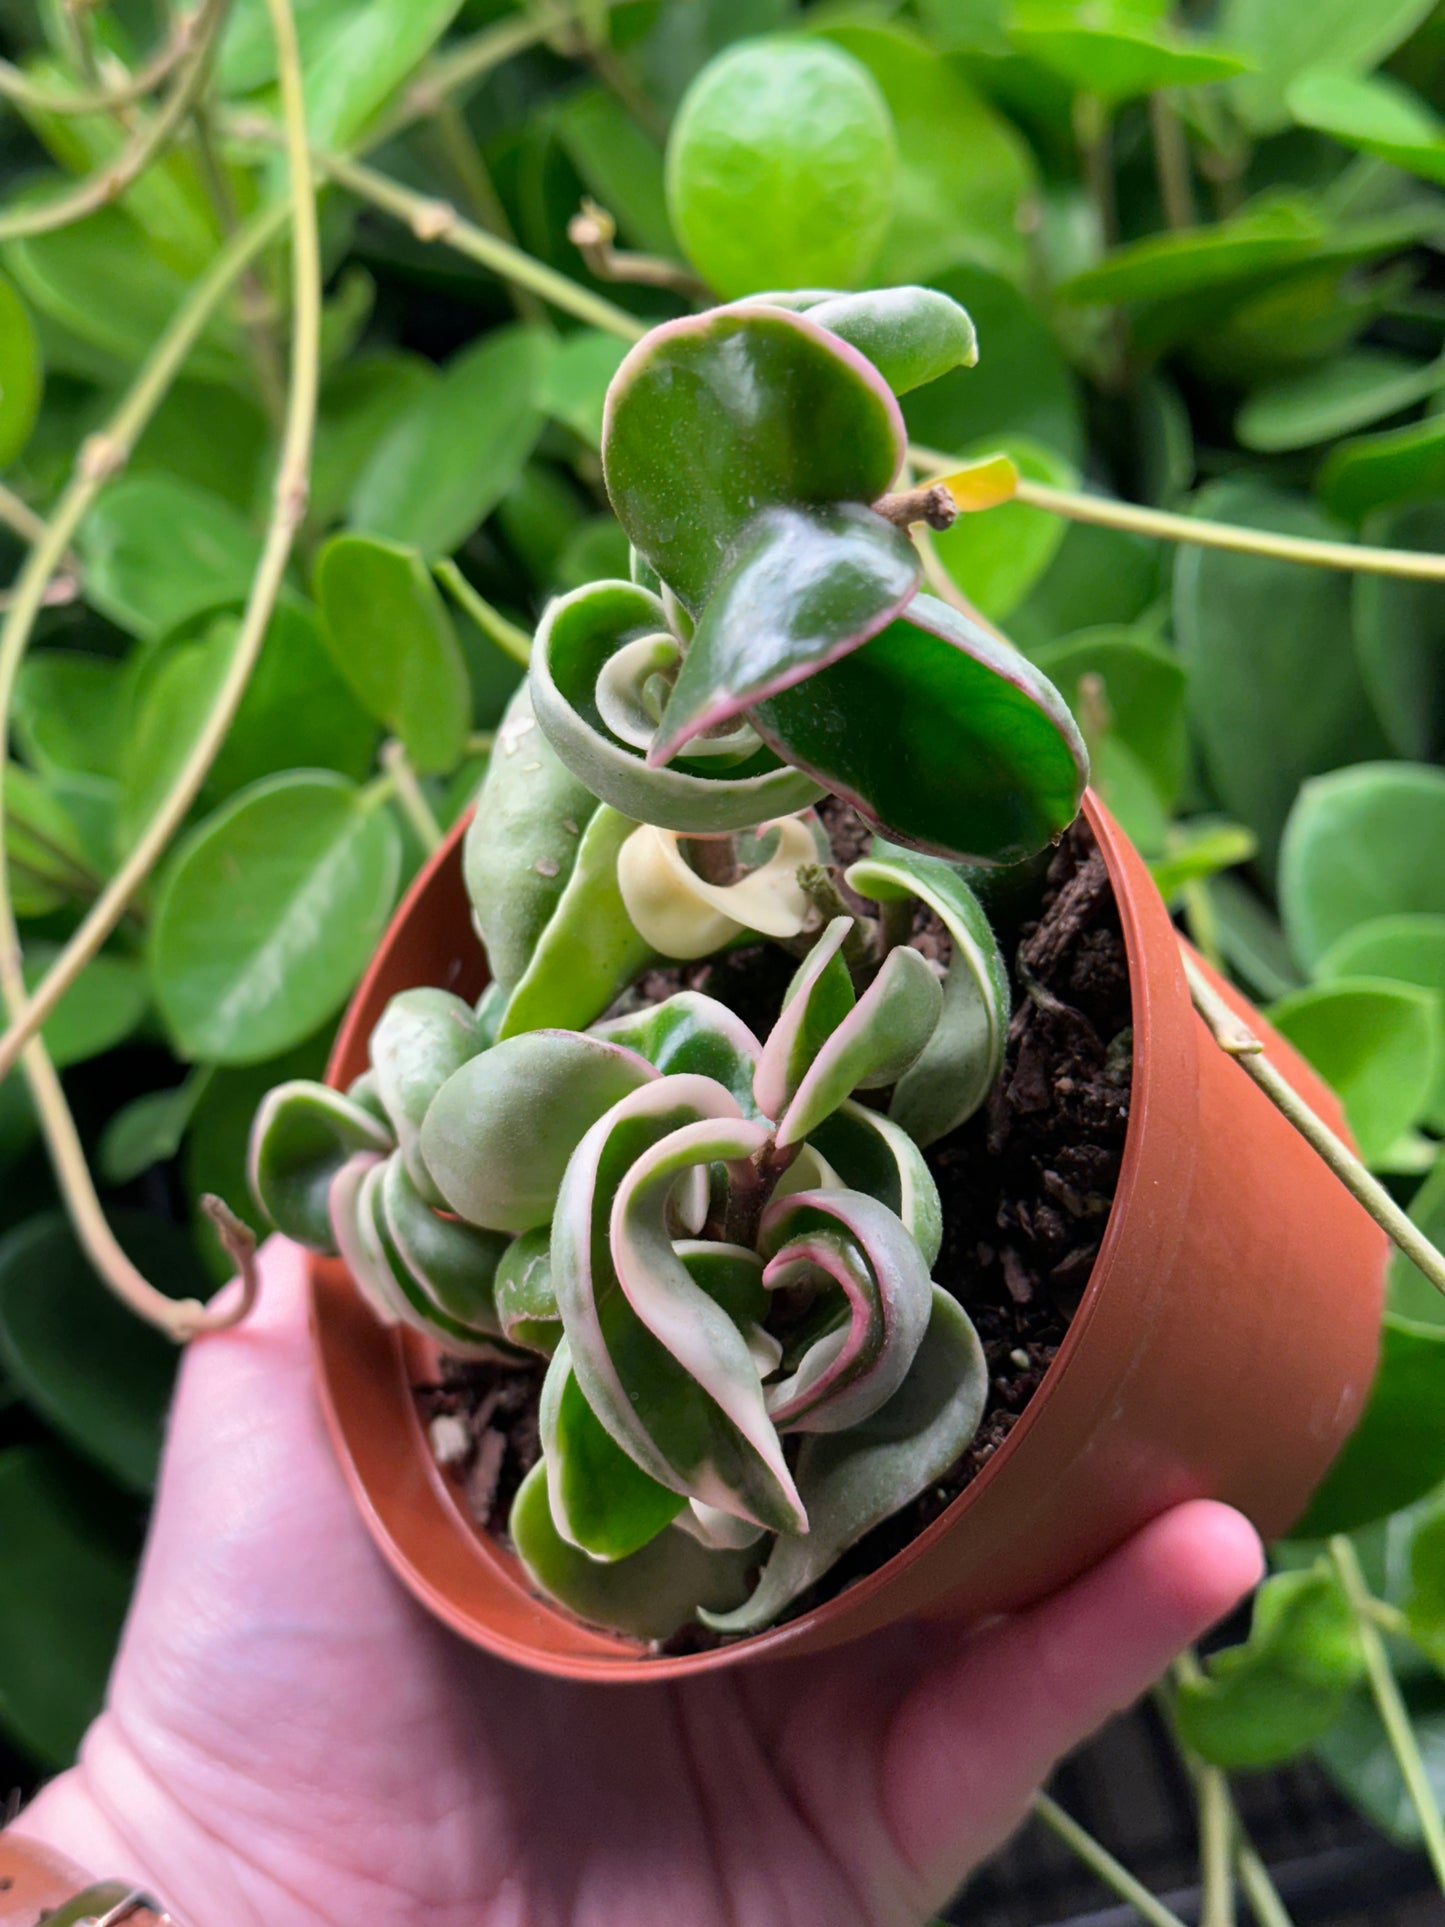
(17, 1239), (1260, 1927)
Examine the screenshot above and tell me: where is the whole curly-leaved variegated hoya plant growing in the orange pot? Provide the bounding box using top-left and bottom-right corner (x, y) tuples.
(252, 289), (1085, 1638)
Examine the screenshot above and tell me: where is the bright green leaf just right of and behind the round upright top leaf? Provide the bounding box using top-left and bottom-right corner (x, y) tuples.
(816, 21), (1037, 287)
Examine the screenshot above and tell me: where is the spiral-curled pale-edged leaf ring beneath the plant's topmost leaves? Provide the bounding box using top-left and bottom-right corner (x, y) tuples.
(531, 582), (823, 834)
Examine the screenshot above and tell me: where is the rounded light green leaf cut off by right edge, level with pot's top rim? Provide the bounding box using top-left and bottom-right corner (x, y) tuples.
(1279, 763), (1445, 967)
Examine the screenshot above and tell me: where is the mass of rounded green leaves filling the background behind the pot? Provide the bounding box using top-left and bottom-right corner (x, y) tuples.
(0, 0), (1445, 1896)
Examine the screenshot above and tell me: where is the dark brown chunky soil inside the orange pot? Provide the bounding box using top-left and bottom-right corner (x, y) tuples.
(416, 802), (1131, 1653)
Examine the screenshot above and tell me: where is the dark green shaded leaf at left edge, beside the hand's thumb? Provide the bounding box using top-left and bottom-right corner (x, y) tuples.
(0, 1212), (208, 1493)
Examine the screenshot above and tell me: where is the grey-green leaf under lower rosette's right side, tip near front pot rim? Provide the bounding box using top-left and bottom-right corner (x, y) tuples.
(697, 1285), (988, 1632)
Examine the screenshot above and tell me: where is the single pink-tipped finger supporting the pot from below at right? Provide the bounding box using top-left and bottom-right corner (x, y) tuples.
(882, 1499), (1264, 1896)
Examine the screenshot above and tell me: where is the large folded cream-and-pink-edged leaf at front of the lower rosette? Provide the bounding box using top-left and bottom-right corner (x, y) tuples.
(551, 1075), (807, 1528)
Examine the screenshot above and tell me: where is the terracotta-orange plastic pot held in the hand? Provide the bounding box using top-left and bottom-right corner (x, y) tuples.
(312, 796), (1387, 1680)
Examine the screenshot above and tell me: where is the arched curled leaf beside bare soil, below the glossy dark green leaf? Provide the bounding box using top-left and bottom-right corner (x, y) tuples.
(846, 840), (1010, 1145)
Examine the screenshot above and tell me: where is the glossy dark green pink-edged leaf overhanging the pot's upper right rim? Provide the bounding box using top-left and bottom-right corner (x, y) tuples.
(751, 595), (1089, 863)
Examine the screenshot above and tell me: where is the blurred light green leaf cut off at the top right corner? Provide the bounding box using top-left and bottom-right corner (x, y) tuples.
(1218, 0), (1432, 133)
